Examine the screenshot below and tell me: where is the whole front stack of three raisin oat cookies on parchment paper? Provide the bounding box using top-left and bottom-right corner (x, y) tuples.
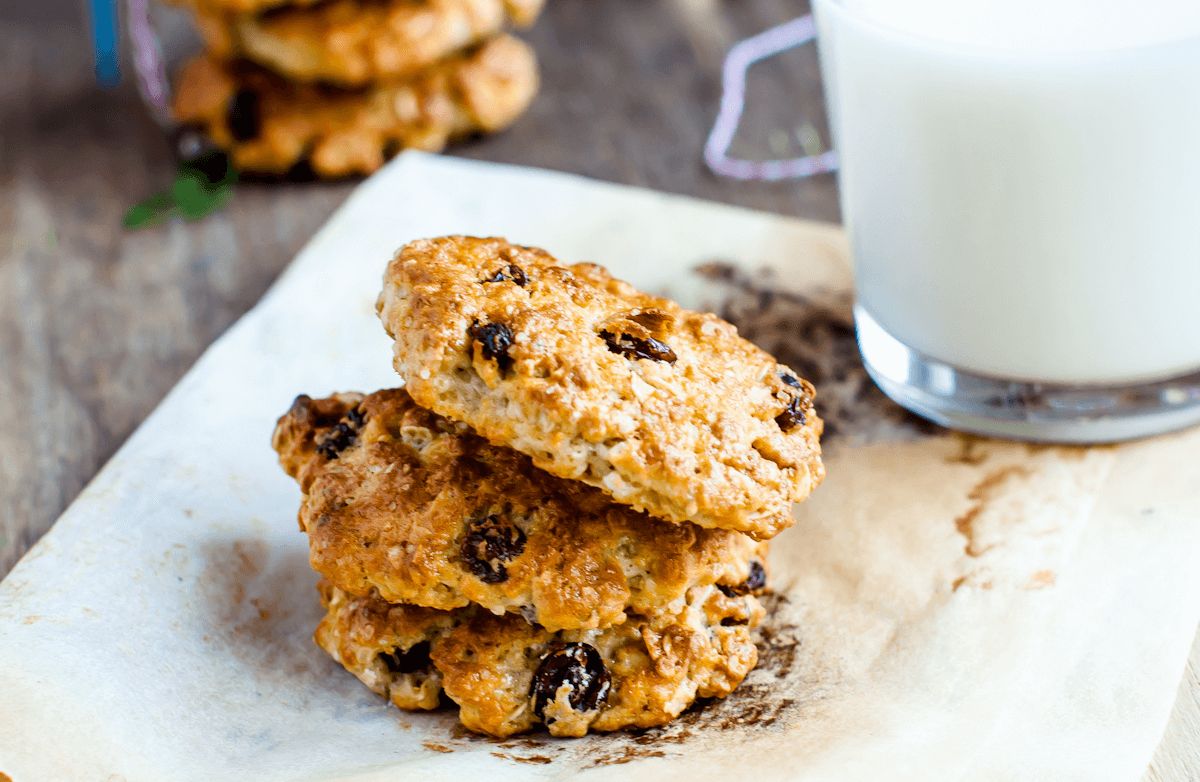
(274, 236), (823, 736)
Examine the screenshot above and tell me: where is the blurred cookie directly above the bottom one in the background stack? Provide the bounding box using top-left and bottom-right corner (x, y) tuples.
(194, 0), (542, 86)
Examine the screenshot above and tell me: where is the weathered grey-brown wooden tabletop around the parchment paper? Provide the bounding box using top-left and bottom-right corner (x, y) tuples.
(0, 0), (1200, 782)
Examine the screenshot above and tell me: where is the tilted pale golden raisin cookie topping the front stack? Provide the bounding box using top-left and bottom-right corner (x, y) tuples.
(377, 236), (824, 540)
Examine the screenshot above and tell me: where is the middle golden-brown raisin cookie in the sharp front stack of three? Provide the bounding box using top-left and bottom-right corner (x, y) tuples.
(272, 390), (766, 631)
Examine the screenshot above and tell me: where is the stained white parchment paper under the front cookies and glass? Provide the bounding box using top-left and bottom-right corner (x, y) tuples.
(0, 155), (1200, 782)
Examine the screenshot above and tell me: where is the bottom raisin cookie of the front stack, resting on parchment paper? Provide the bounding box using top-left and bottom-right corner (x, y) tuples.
(316, 584), (763, 736)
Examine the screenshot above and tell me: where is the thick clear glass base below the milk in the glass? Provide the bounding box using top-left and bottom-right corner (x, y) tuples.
(854, 306), (1200, 443)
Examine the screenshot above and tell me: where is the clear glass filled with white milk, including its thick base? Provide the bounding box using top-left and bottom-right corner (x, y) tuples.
(814, 0), (1200, 441)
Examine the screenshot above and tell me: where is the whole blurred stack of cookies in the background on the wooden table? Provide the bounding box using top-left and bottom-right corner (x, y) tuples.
(172, 0), (544, 178)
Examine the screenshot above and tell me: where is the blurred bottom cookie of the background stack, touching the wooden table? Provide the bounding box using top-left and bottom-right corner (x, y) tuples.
(173, 35), (538, 178)
